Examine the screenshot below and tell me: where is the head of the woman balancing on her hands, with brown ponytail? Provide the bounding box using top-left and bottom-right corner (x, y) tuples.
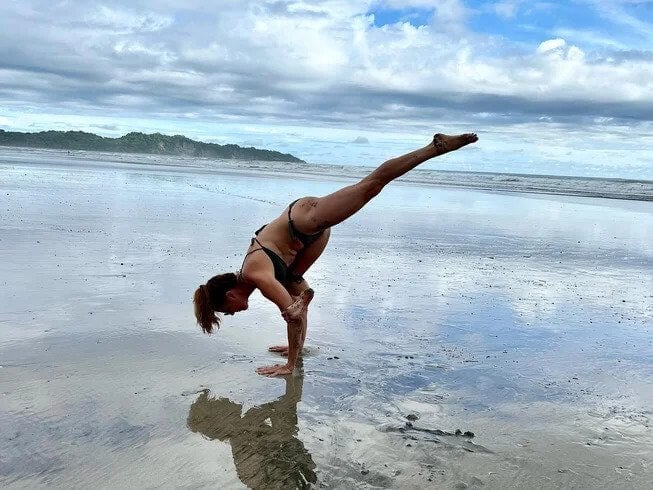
(193, 272), (247, 333)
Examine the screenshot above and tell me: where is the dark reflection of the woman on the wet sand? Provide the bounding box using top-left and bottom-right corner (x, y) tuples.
(188, 375), (317, 488)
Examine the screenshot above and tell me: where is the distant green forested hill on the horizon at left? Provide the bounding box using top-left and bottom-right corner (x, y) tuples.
(0, 129), (305, 163)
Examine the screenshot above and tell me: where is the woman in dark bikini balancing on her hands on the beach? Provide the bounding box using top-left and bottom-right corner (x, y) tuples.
(193, 133), (478, 376)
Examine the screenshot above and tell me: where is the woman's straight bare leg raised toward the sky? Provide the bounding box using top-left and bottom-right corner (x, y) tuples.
(292, 133), (478, 233)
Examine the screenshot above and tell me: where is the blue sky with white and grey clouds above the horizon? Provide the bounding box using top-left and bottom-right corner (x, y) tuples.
(0, 0), (653, 180)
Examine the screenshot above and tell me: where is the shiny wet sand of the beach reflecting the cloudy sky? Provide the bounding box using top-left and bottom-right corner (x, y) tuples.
(0, 154), (653, 489)
